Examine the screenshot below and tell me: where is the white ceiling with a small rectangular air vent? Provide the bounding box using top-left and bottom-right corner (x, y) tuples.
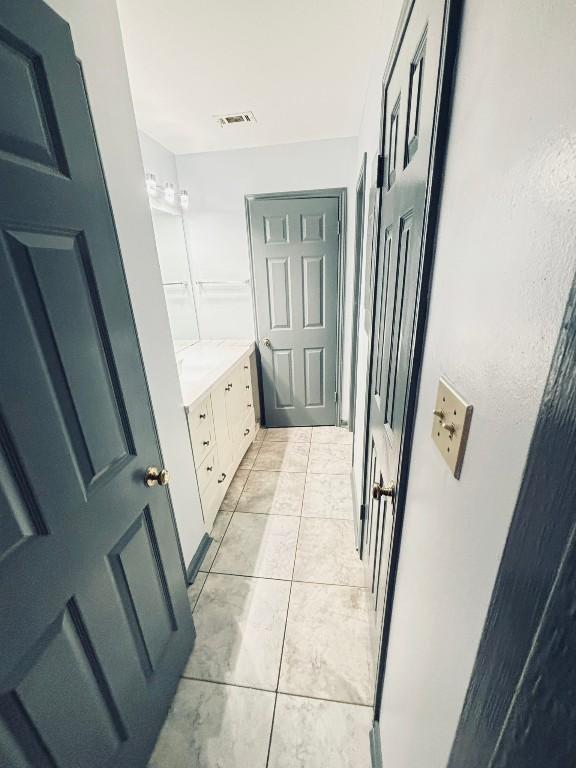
(118, 0), (382, 154)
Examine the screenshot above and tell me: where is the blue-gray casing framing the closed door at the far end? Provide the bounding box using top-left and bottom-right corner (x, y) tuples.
(244, 187), (347, 426)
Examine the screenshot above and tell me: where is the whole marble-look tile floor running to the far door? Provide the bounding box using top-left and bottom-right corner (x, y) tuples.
(150, 427), (374, 768)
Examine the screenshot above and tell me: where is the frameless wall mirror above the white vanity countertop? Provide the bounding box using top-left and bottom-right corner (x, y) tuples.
(152, 208), (200, 351)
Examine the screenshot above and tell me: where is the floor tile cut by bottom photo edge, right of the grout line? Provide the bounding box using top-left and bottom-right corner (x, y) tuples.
(268, 694), (372, 768)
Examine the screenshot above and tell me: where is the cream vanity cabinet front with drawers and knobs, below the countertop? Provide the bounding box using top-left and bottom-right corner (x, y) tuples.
(188, 355), (256, 532)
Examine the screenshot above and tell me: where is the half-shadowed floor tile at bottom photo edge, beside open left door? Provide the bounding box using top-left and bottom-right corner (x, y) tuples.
(149, 680), (274, 768)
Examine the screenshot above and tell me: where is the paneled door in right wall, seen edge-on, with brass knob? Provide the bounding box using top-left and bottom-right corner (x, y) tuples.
(363, 0), (444, 680)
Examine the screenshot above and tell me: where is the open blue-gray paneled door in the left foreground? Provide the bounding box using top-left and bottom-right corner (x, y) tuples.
(0, 0), (193, 768)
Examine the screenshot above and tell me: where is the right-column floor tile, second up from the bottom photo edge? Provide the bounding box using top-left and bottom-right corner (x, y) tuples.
(278, 582), (374, 704)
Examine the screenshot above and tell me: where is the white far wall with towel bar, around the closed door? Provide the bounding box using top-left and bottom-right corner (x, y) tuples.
(176, 138), (357, 418)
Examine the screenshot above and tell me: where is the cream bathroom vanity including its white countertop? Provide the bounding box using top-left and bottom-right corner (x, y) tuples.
(177, 341), (258, 533)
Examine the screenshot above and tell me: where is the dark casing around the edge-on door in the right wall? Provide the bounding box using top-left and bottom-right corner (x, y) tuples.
(359, 0), (462, 752)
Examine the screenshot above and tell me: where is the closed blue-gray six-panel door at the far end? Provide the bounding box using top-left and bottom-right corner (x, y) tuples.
(249, 197), (340, 427)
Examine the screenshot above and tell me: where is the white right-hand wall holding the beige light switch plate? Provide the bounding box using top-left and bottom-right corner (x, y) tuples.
(356, 0), (576, 768)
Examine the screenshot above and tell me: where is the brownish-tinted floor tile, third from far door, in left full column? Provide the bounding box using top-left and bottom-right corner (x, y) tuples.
(236, 470), (306, 516)
